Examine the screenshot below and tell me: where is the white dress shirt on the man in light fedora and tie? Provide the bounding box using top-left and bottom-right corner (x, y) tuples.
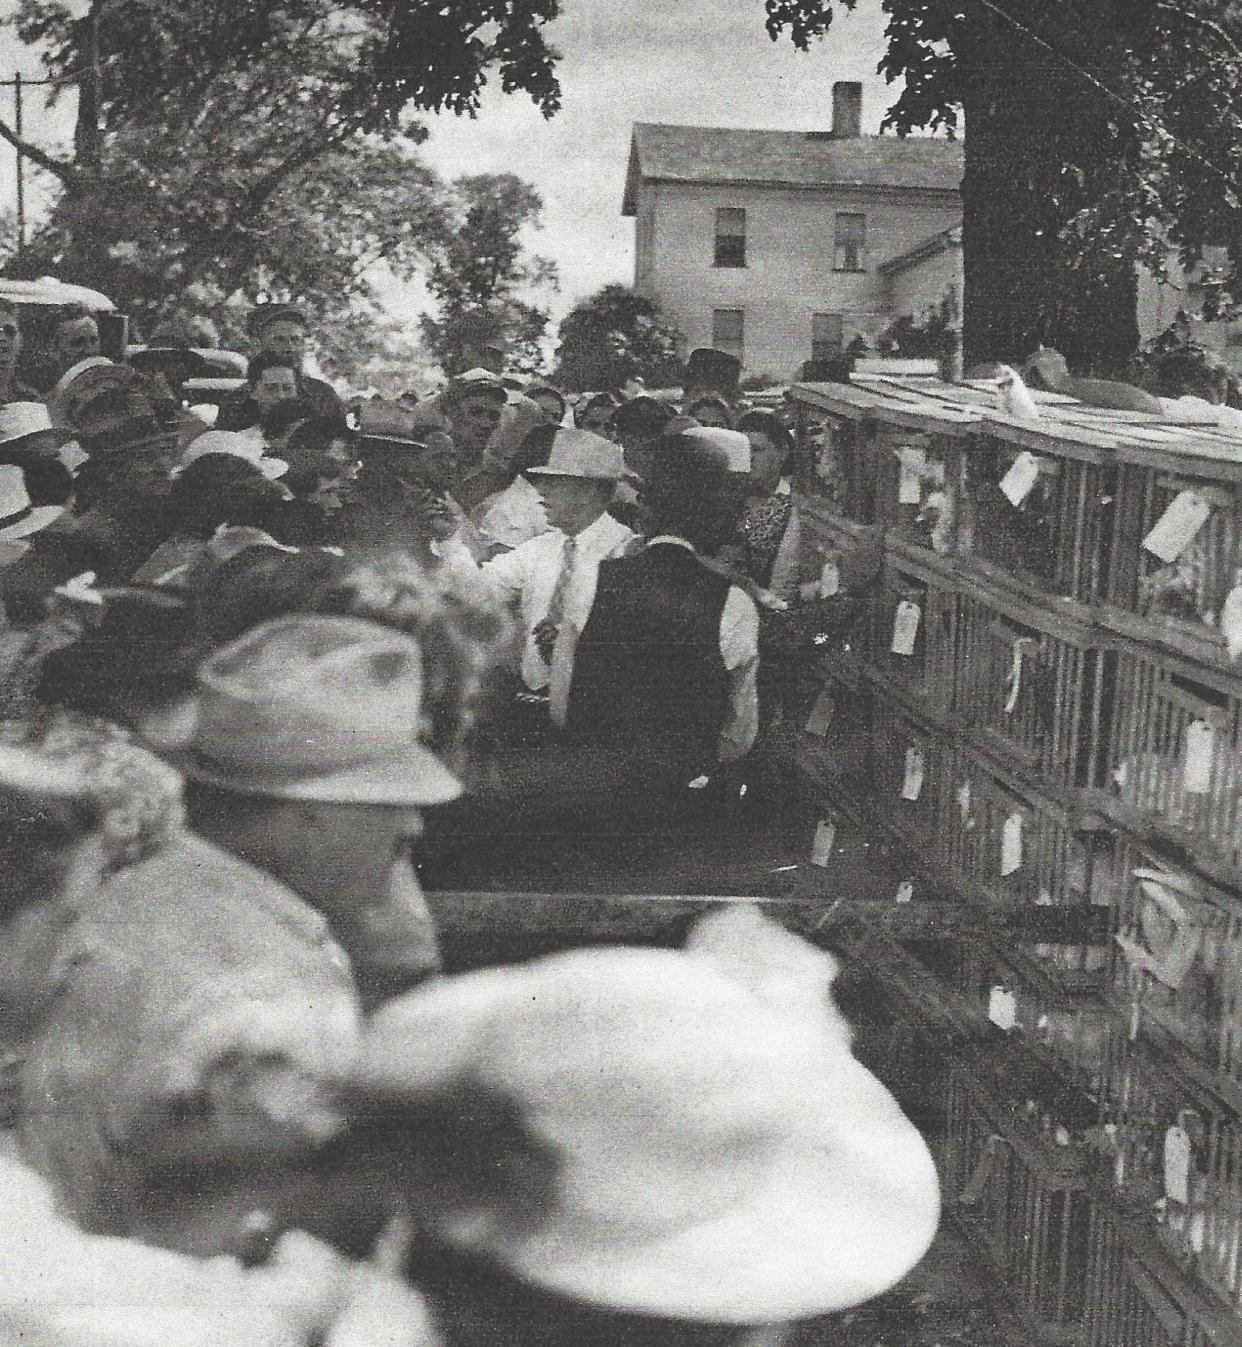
(481, 515), (636, 692)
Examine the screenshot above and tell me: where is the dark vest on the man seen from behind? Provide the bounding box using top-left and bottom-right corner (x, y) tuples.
(566, 543), (730, 765)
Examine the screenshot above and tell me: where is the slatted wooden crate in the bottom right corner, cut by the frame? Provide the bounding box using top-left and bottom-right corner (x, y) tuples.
(1083, 1204), (1242, 1347)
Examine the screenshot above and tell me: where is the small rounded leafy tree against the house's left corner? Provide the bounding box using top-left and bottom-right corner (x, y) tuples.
(554, 284), (682, 392)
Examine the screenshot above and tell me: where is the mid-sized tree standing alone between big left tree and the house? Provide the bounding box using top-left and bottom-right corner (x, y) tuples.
(422, 174), (556, 373)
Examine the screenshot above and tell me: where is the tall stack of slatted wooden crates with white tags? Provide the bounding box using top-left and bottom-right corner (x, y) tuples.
(792, 377), (1242, 1347)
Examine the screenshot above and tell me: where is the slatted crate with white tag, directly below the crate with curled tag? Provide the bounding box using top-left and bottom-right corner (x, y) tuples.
(939, 748), (1114, 921)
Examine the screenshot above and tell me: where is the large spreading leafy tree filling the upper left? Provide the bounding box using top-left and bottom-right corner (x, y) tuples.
(0, 0), (559, 369)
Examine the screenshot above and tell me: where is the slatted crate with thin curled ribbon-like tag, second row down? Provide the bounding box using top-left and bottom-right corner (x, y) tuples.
(950, 579), (1115, 788)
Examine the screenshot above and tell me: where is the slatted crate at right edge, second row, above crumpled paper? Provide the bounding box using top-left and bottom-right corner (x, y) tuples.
(1109, 643), (1242, 873)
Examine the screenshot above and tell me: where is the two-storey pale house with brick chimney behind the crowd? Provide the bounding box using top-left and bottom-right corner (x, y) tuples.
(622, 82), (962, 379)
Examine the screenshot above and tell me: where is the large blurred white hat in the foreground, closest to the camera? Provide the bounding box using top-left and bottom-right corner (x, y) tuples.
(358, 915), (939, 1324)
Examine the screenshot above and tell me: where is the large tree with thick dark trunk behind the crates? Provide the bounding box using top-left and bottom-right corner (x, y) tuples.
(766, 0), (1242, 364)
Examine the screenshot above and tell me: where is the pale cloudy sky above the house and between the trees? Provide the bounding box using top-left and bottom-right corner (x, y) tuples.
(0, 0), (896, 319)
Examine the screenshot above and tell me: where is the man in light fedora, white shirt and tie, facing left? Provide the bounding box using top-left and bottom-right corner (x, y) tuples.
(482, 427), (636, 732)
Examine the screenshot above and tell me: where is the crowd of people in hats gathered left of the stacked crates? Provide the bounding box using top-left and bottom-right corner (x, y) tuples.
(0, 304), (936, 1347)
